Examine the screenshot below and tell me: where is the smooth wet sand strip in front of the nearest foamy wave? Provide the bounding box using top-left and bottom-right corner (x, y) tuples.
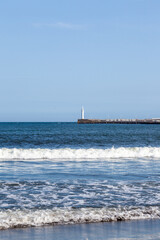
(0, 220), (160, 240)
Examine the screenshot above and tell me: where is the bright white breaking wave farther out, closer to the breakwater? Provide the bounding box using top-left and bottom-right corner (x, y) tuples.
(0, 147), (160, 160)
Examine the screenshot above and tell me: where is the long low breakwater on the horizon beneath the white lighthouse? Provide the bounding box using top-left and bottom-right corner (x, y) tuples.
(77, 118), (160, 124)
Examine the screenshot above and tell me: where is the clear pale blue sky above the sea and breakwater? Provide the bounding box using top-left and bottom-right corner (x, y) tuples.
(0, 0), (160, 122)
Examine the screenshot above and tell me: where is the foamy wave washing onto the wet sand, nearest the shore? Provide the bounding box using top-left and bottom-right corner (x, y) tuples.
(0, 207), (160, 230)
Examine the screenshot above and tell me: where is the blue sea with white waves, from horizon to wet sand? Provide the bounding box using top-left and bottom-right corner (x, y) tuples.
(0, 123), (160, 230)
